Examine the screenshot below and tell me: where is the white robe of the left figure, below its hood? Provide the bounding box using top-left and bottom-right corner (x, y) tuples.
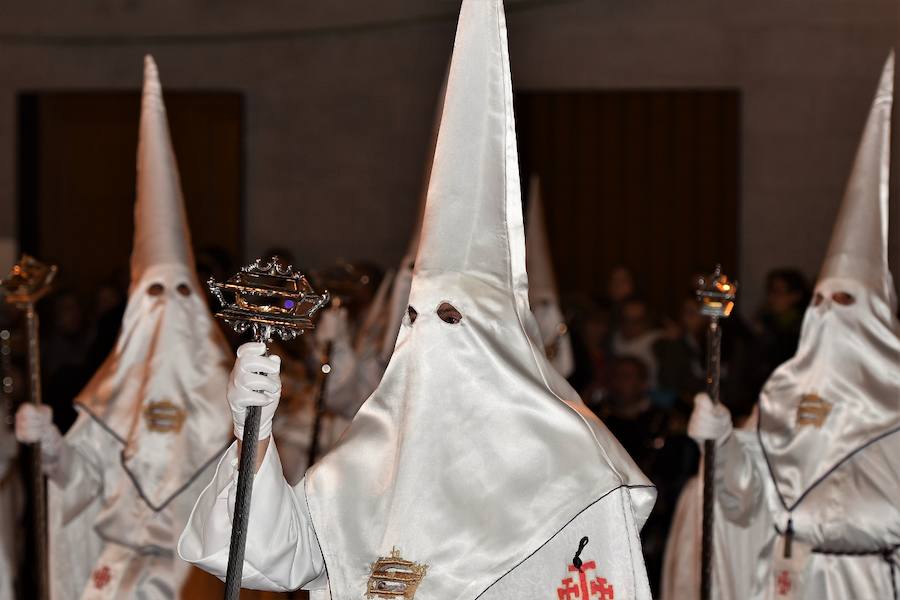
(48, 412), (215, 600)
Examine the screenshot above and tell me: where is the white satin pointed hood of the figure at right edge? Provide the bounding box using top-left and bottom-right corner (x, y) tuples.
(759, 53), (900, 510)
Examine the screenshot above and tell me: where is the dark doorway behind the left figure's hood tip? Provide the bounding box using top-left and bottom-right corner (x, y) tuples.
(19, 92), (243, 300)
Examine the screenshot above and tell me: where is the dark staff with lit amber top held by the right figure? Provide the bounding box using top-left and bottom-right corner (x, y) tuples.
(697, 265), (737, 600)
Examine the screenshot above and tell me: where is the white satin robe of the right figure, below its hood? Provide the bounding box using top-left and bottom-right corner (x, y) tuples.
(716, 426), (900, 600)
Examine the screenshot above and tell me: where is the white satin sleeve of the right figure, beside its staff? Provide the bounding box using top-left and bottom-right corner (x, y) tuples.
(716, 430), (763, 527)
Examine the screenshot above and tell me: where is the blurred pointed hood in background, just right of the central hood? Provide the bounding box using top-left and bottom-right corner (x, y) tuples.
(525, 176), (575, 377)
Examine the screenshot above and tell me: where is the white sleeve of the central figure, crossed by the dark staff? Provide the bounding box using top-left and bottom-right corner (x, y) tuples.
(178, 440), (325, 592)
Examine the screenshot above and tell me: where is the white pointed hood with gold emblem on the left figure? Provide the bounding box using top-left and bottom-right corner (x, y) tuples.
(76, 56), (231, 516)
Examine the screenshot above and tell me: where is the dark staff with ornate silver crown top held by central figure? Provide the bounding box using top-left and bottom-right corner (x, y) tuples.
(209, 257), (329, 600)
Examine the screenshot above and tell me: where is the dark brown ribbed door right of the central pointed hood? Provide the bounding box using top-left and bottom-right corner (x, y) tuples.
(517, 90), (740, 312)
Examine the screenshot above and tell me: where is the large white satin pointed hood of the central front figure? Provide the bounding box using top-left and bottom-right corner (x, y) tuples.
(306, 0), (654, 600)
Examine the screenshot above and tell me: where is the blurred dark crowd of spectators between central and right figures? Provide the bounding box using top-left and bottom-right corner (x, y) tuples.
(563, 266), (810, 589)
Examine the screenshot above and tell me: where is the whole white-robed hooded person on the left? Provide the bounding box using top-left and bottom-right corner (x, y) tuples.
(16, 56), (231, 600)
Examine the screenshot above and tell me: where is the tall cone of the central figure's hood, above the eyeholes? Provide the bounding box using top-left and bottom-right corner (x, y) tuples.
(413, 0), (527, 294)
